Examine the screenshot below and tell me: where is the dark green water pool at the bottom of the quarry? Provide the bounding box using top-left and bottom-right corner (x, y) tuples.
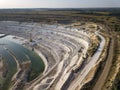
(0, 36), (45, 88)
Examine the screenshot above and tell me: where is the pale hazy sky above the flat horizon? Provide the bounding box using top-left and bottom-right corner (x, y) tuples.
(0, 0), (120, 8)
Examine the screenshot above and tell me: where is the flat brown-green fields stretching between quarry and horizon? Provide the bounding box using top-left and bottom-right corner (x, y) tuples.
(0, 8), (120, 31)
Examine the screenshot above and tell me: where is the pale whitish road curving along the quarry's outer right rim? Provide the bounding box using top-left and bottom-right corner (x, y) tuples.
(68, 32), (105, 90)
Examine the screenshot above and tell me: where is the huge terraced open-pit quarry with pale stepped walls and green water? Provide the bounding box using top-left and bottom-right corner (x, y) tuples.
(0, 21), (109, 90)
